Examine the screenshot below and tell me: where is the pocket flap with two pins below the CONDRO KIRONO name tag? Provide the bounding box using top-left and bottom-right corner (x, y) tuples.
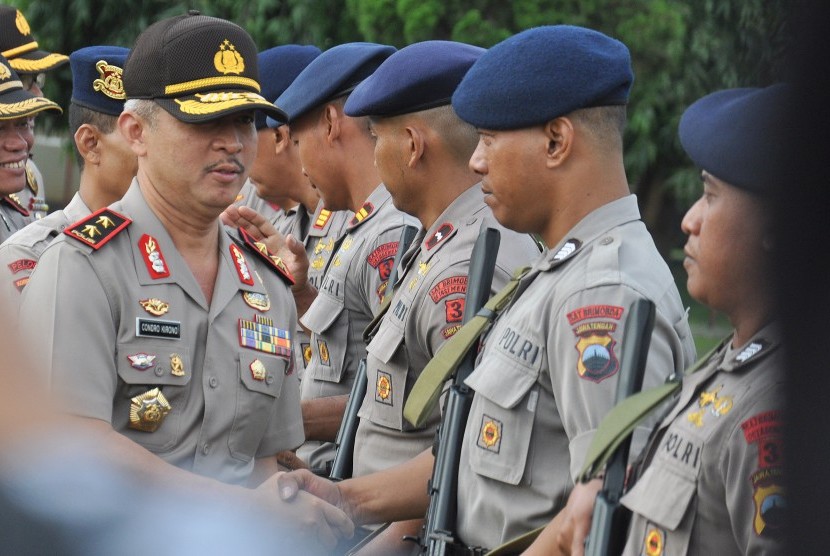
(116, 342), (193, 386)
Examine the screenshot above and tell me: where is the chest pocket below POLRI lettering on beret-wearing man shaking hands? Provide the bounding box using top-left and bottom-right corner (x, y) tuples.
(465, 361), (539, 485)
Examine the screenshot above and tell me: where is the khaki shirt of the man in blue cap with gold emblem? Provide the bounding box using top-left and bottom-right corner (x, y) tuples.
(0, 193), (92, 314)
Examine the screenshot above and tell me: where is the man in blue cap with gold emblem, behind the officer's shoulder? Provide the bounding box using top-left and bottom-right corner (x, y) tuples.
(0, 46), (137, 308)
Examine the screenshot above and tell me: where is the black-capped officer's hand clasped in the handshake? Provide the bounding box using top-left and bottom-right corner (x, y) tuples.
(254, 473), (354, 554)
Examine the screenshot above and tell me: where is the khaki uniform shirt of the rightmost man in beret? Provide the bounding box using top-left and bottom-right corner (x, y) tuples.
(622, 325), (792, 556)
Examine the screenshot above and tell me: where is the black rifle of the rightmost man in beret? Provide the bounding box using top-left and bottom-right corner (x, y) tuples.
(585, 299), (654, 556)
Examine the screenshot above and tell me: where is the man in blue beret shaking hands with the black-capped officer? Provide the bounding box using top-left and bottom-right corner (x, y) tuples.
(284, 22), (694, 551)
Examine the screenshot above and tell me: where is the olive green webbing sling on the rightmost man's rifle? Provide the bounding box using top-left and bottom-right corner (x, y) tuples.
(577, 336), (731, 482)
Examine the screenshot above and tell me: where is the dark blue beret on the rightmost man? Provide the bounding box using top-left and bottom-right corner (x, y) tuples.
(679, 84), (791, 193)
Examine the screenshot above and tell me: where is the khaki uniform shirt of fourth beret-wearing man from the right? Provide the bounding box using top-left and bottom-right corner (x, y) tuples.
(300, 185), (415, 468)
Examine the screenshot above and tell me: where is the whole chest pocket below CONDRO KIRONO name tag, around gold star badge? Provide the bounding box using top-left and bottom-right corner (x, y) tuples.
(112, 340), (192, 452)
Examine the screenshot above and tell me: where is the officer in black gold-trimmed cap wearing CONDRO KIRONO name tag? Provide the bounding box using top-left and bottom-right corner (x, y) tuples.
(21, 12), (351, 545)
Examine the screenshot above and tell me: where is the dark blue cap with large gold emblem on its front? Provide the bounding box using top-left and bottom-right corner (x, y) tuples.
(69, 46), (130, 116)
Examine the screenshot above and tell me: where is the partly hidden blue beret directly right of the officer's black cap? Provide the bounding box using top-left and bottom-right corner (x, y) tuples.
(255, 44), (320, 129)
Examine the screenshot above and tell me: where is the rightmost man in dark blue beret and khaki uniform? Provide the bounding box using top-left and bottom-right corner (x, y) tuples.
(548, 85), (789, 555)
